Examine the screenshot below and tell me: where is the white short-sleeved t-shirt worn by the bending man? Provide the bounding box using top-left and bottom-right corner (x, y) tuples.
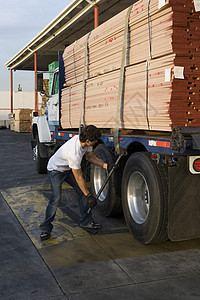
(47, 135), (92, 172)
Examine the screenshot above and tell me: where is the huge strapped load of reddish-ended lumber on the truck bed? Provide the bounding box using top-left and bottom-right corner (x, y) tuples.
(61, 0), (200, 131)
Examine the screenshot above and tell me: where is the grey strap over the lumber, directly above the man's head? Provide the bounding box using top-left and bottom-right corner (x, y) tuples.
(79, 32), (90, 134)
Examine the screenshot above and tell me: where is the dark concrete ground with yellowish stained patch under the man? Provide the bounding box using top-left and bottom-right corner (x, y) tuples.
(0, 129), (200, 300)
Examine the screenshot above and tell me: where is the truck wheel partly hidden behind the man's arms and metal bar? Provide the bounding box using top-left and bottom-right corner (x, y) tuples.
(90, 144), (122, 217)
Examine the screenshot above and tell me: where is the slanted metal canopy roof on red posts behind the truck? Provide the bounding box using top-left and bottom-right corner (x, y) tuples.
(5, 0), (136, 71)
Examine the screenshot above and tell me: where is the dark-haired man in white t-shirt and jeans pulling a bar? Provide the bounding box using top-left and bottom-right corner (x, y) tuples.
(40, 125), (108, 240)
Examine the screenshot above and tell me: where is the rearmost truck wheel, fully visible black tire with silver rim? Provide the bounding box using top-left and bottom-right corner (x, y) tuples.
(122, 152), (168, 244)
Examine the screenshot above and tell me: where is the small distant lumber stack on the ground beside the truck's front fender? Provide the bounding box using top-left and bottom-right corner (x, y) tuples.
(14, 108), (32, 132)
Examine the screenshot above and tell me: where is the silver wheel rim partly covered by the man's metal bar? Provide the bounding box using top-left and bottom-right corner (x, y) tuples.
(94, 166), (109, 201)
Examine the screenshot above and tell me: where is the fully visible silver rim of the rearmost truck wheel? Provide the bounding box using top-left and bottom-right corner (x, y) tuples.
(127, 171), (150, 224)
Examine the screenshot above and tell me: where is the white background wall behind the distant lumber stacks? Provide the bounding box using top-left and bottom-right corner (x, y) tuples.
(0, 91), (42, 120)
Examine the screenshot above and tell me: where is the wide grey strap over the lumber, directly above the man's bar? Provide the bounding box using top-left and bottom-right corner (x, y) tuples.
(114, 5), (133, 154)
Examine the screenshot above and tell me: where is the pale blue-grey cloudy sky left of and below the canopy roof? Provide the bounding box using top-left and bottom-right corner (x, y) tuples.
(0, 0), (72, 92)
